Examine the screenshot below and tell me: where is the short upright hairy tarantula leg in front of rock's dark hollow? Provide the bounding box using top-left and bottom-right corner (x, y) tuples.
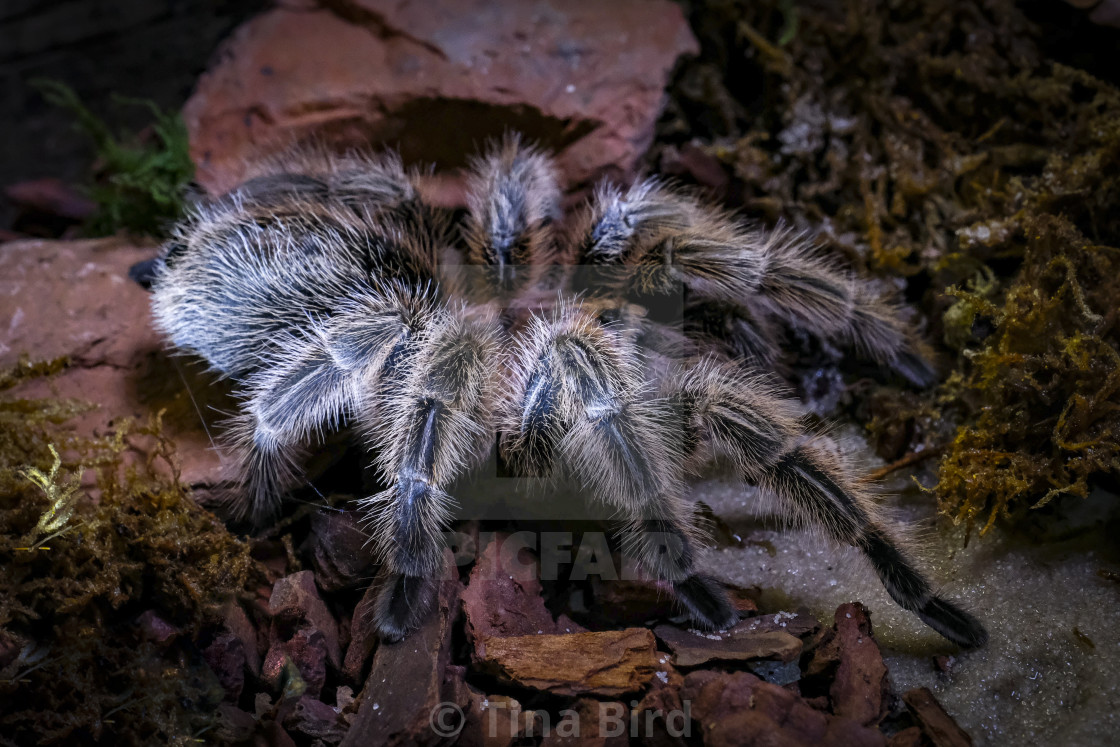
(463, 134), (560, 289)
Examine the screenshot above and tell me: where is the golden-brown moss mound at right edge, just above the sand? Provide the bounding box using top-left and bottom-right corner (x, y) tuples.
(935, 216), (1120, 533)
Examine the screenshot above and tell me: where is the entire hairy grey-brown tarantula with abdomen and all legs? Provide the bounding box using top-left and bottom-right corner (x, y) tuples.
(142, 137), (987, 646)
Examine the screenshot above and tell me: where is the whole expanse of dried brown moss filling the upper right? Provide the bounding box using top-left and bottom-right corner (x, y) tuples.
(662, 0), (1120, 531)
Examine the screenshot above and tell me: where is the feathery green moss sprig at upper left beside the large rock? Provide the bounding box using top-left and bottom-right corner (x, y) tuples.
(35, 80), (195, 236)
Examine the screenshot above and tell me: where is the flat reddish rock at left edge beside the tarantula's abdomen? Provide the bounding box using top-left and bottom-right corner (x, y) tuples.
(0, 239), (234, 485)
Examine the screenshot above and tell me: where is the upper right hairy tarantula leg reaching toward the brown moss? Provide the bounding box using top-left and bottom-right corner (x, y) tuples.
(577, 180), (936, 386)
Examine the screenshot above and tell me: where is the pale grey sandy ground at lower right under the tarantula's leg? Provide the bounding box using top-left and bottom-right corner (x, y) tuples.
(696, 430), (1120, 746)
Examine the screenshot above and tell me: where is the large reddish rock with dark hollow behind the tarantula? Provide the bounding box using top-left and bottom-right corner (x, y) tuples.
(184, 0), (698, 193)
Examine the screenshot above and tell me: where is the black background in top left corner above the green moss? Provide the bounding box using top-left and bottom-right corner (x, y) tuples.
(0, 0), (265, 192)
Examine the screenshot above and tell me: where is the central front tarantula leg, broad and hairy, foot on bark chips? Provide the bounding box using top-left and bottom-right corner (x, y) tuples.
(503, 308), (738, 629)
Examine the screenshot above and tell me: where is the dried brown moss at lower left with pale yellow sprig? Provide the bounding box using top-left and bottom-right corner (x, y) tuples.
(0, 366), (260, 745)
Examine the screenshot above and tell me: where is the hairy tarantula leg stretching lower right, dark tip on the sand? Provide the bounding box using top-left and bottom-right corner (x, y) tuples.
(676, 362), (988, 648)
